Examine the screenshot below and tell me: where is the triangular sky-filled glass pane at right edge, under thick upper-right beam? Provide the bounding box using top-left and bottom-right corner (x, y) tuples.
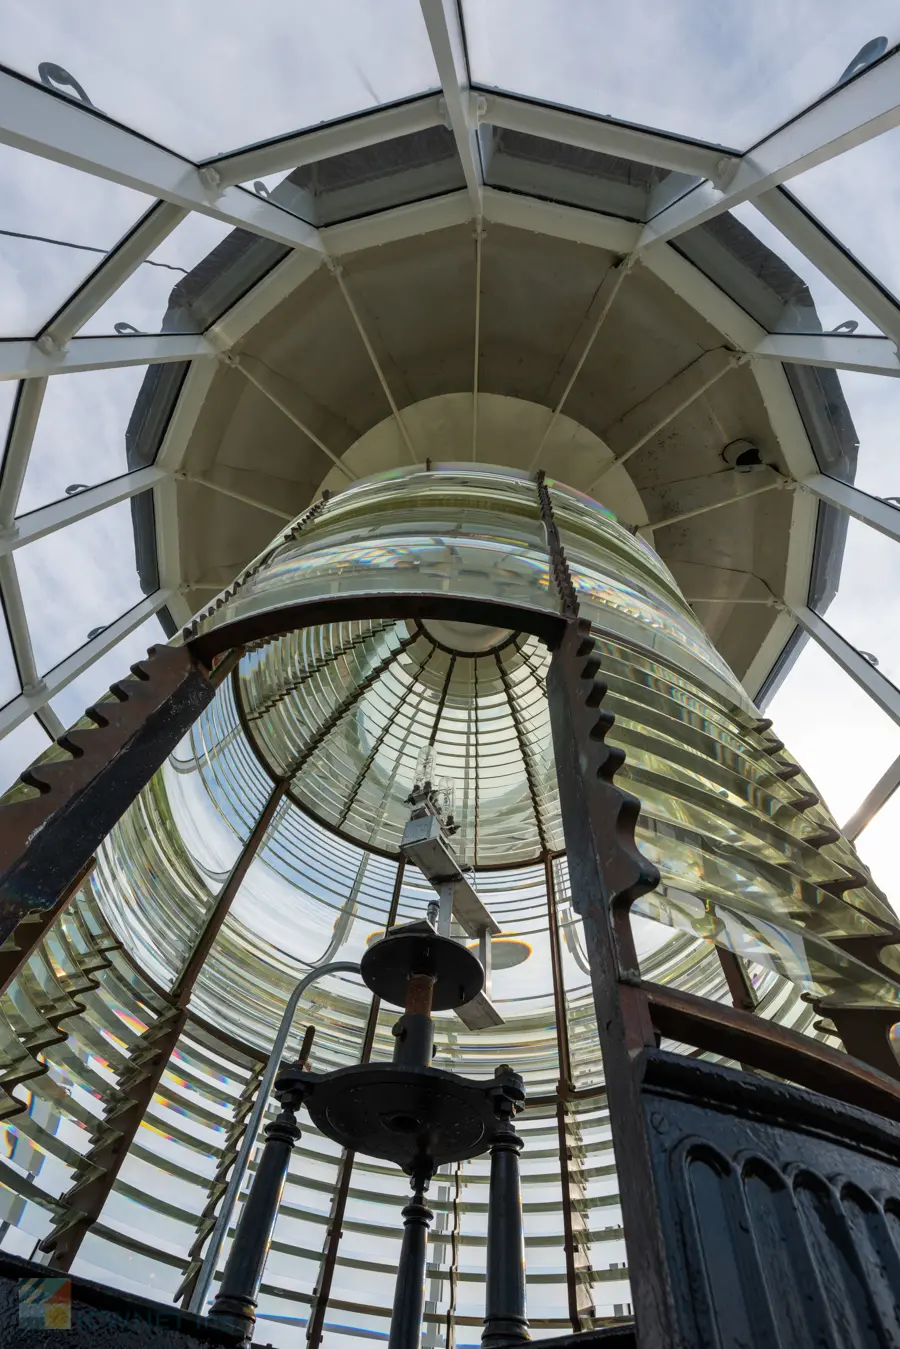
(788, 127), (900, 295)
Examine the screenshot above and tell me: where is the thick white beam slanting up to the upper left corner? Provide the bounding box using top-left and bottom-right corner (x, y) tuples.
(0, 71), (321, 252)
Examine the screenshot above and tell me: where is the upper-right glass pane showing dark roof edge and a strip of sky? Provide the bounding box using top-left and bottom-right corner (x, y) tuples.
(675, 202), (878, 336)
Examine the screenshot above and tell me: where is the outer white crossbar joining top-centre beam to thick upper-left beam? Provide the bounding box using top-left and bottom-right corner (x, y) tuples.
(204, 94), (444, 186)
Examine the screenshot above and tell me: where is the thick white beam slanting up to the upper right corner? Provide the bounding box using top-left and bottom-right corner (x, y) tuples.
(641, 53), (900, 248)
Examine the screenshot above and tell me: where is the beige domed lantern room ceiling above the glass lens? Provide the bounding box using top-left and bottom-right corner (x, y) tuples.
(167, 221), (812, 696)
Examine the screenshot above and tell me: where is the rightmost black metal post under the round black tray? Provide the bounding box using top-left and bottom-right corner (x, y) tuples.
(482, 1064), (532, 1349)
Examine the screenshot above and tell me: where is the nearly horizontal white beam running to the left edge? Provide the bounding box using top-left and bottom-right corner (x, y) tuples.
(0, 333), (217, 379)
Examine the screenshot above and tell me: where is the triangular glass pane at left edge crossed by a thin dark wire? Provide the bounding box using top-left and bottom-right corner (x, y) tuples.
(0, 141), (151, 337)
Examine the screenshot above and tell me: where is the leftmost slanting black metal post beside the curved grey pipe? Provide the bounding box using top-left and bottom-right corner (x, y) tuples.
(209, 1027), (313, 1345)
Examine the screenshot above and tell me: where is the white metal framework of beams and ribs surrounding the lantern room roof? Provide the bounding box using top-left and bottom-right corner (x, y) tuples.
(0, 15), (900, 852)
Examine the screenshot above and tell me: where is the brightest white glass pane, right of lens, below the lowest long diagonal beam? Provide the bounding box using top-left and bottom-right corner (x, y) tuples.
(766, 631), (900, 824)
